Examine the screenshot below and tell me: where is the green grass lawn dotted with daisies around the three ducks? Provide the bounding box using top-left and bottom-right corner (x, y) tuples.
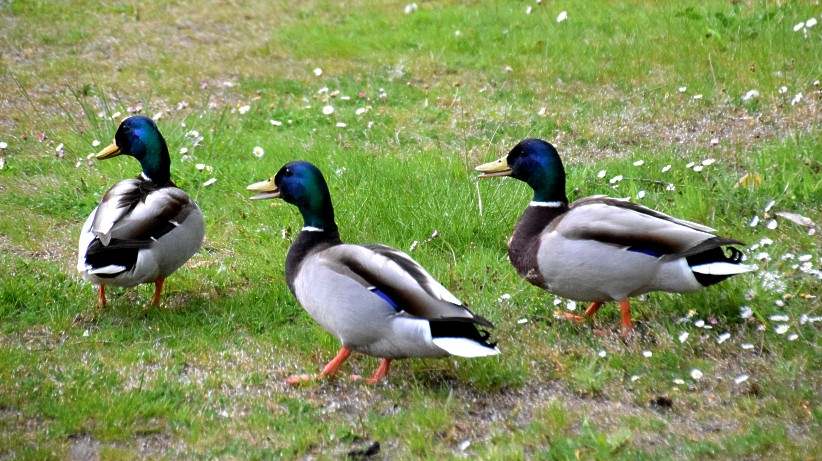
(0, 0), (822, 459)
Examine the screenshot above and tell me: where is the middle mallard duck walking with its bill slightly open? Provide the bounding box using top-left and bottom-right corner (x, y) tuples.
(248, 161), (499, 385)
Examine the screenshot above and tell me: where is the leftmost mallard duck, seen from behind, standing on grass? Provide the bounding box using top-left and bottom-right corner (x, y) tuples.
(77, 115), (205, 307)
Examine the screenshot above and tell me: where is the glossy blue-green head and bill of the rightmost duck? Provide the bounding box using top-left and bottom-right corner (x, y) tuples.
(476, 139), (568, 203)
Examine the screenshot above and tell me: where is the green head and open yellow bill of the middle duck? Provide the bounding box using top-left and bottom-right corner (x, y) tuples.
(247, 160), (336, 230)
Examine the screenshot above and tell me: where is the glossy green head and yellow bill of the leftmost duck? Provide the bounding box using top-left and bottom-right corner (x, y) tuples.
(97, 115), (171, 183)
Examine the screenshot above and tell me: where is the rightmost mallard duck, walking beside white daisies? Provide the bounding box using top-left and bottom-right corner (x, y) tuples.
(476, 139), (756, 333)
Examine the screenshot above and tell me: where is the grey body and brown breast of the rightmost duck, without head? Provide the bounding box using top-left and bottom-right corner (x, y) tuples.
(509, 197), (749, 302)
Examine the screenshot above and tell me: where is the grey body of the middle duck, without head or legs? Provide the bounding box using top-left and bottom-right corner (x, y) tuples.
(286, 230), (499, 358)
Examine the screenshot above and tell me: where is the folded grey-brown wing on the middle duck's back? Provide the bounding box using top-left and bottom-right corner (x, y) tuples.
(319, 244), (492, 327)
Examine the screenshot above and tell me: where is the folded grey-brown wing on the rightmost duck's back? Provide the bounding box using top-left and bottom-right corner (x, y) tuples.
(546, 197), (741, 257)
